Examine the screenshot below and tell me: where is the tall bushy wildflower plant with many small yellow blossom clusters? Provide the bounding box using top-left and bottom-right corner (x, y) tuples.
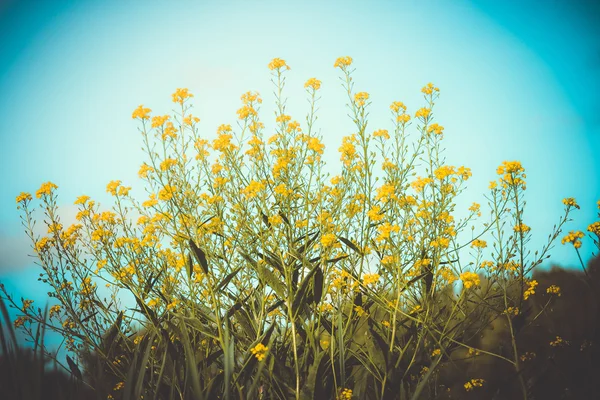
(5, 57), (598, 399)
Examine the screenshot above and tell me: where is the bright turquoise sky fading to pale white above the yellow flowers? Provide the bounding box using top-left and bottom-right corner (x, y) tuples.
(0, 0), (600, 344)
